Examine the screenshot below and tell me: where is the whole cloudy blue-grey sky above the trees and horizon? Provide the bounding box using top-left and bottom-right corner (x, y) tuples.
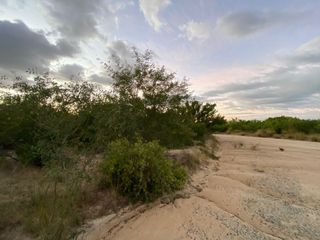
(0, 0), (320, 119)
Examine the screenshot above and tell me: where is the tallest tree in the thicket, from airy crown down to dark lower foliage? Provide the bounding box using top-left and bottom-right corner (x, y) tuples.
(106, 50), (194, 147)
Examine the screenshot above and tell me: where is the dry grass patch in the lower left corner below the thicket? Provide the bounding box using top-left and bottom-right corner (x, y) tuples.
(0, 154), (127, 240)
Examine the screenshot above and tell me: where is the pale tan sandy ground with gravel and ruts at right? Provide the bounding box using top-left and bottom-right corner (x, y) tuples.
(82, 135), (320, 240)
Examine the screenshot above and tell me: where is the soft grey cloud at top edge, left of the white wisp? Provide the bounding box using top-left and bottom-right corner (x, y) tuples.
(44, 0), (114, 41)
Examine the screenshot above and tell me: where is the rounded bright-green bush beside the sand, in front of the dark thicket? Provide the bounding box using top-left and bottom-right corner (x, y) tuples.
(101, 139), (187, 201)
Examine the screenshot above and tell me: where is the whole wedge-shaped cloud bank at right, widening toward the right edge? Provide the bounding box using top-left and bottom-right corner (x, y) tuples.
(202, 38), (320, 115)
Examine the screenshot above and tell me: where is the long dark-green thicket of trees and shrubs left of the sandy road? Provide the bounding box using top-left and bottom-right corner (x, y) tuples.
(0, 51), (225, 166)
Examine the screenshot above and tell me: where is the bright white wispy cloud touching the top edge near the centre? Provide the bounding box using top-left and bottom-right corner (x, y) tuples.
(139, 0), (171, 32)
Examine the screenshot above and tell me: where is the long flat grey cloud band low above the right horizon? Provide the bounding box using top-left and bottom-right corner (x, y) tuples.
(203, 67), (320, 108)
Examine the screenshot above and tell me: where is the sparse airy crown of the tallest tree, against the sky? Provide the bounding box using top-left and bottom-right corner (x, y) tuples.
(105, 49), (189, 112)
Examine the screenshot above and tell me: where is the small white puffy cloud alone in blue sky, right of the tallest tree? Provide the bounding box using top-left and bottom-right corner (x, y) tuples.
(180, 21), (212, 41)
